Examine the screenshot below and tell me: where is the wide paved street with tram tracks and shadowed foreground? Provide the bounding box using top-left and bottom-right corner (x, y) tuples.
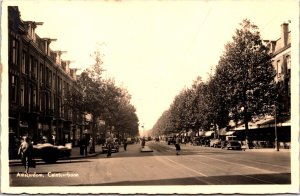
(9, 141), (291, 186)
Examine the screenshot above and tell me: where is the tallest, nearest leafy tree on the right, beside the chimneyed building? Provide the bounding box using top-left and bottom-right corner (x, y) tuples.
(217, 19), (275, 145)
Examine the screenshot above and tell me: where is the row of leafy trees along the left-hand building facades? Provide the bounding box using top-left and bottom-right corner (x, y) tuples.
(65, 51), (139, 151)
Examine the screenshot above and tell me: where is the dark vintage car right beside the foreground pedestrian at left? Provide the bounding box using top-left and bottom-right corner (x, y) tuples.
(33, 143), (72, 163)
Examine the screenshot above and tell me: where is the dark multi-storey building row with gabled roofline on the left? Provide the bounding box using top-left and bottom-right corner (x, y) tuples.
(8, 6), (84, 156)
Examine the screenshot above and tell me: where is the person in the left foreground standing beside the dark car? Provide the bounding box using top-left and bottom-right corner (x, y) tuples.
(18, 137), (35, 174)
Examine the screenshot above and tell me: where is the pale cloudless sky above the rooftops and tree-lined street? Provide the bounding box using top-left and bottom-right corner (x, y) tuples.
(4, 0), (298, 130)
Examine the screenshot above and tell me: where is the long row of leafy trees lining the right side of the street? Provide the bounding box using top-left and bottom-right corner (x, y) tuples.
(152, 19), (278, 141)
